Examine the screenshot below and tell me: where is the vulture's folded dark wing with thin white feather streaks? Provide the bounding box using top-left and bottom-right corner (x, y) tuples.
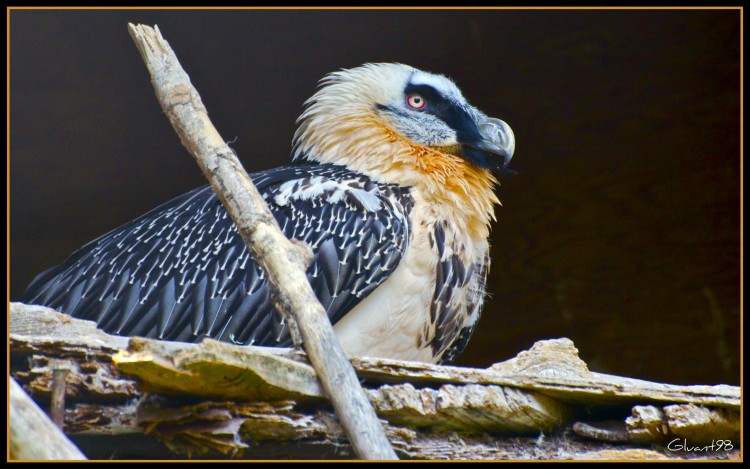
(23, 164), (412, 345)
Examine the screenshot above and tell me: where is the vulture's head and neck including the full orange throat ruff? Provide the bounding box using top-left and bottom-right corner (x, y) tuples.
(293, 63), (515, 234)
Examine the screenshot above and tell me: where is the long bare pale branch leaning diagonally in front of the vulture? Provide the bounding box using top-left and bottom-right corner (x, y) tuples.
(128, 24), (396, 459)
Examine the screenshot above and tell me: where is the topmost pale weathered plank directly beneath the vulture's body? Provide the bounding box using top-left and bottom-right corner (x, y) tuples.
(11, 303), (740, 410)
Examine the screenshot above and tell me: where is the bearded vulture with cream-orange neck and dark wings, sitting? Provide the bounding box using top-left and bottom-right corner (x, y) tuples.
(21, 63), (515, 363)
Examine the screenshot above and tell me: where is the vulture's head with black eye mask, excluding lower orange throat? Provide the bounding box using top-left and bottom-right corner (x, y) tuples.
(294, 63), (515, 183)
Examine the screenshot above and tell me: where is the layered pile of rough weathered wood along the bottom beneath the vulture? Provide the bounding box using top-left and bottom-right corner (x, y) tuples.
(10, 303), (740, 459)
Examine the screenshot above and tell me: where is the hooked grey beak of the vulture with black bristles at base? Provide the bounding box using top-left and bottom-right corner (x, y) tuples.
(459, 116), (516, 173)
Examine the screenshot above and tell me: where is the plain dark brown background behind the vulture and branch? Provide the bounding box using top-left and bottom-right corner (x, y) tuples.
(10, 10), (740, 383)
